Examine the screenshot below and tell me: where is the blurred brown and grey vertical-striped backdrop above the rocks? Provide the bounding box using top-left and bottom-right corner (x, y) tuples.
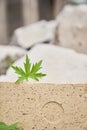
(0, 0), (87, 44)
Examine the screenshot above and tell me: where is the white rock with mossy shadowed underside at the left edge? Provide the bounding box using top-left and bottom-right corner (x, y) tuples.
(0, 45), (26, 75)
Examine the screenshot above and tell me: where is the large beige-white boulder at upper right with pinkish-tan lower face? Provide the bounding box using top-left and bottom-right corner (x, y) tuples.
(55, 5), (87, 53)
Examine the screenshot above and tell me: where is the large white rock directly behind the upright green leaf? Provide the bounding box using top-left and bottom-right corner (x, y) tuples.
(1, 44), (87, 83)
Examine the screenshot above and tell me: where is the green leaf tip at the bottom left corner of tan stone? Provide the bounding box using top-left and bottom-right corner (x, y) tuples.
(0, 122), (22, 130)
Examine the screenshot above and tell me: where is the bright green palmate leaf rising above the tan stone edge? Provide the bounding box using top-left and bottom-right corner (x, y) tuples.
(12, 55), (46, 83)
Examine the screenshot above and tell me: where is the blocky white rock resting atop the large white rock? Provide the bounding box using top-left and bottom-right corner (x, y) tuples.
(11, 21), (55, 48)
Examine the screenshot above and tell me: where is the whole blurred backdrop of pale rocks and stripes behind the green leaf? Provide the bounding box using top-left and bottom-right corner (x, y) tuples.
(0, 0), (87, 83)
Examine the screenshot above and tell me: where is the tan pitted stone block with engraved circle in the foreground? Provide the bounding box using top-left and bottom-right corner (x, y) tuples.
(0, 83), (87, 130)
